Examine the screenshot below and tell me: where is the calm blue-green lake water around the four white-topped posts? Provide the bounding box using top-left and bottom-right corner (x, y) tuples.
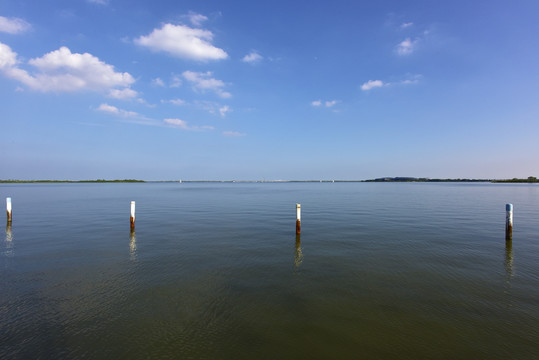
(0, 183), (539, 359)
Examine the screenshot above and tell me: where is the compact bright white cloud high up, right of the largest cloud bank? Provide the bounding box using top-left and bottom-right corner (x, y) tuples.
(135, 24), (228, 61)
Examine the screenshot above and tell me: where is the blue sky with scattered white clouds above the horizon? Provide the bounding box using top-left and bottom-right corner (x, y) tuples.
(0, 0), (539, 180)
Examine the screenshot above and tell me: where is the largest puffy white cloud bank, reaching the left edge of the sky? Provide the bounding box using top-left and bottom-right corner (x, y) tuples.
(0, 43), (135, 94)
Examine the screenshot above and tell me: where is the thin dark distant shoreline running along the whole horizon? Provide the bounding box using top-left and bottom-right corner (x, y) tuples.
(0, 176), (539, 184)
